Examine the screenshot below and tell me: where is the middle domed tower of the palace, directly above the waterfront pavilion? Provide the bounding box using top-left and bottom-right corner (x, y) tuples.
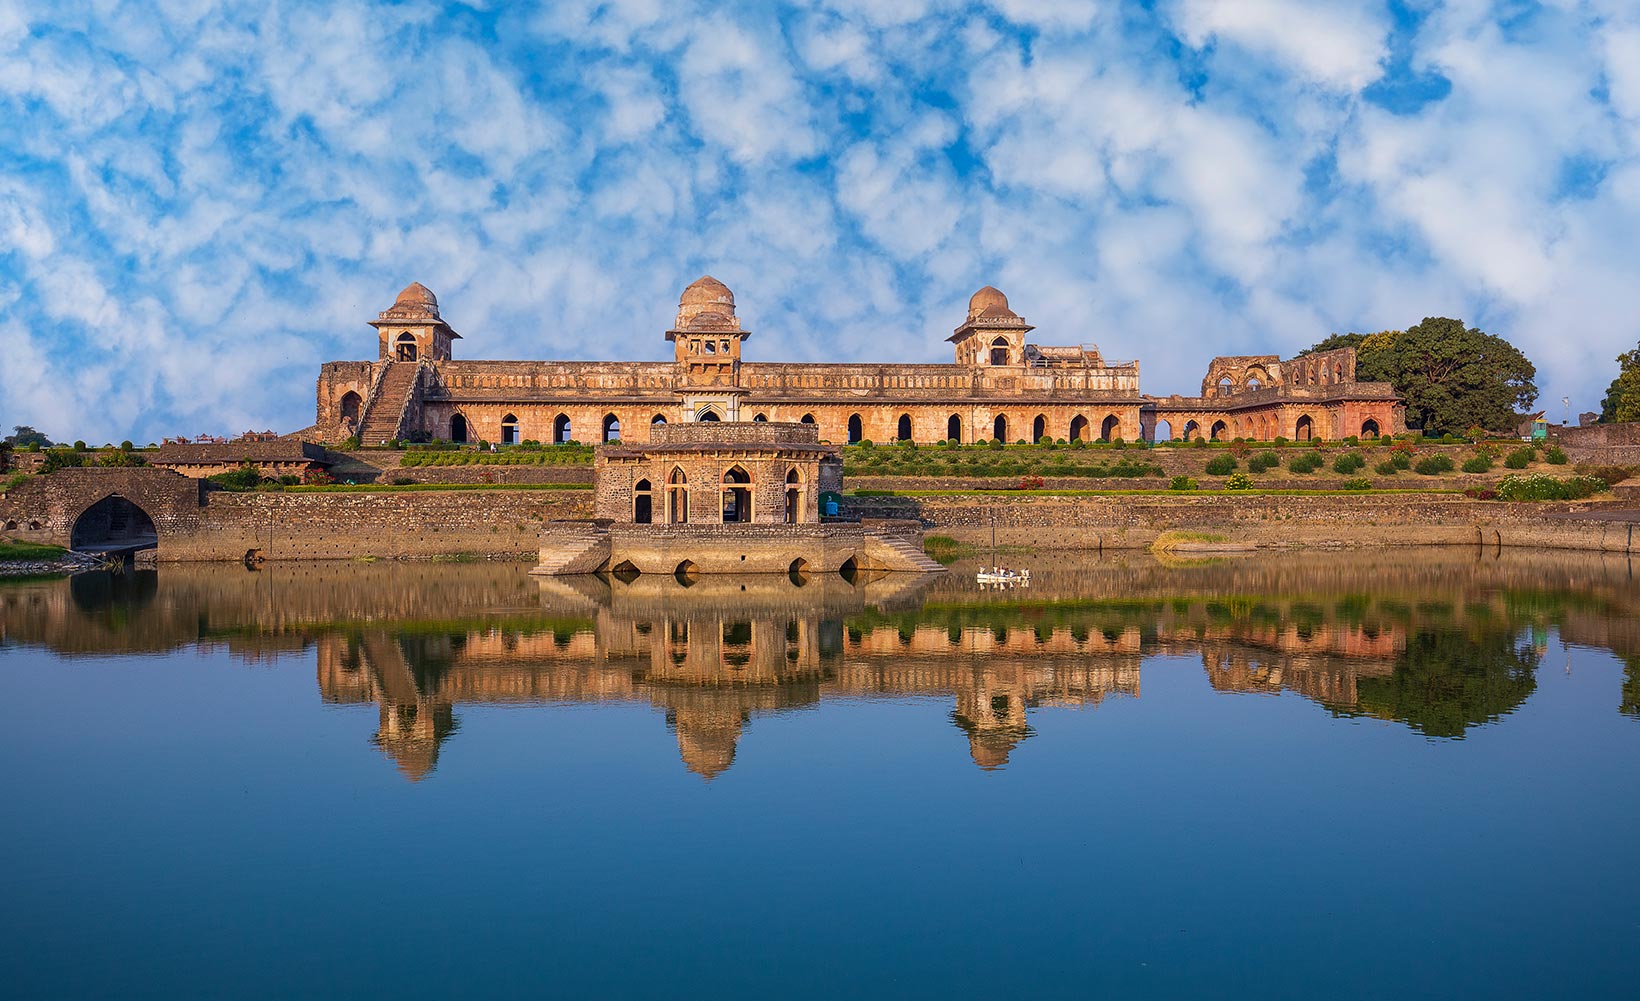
(666, 274), (751, 420)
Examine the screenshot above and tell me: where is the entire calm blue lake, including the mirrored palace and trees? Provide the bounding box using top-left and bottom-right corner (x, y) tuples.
(0, 553), (1640, 998)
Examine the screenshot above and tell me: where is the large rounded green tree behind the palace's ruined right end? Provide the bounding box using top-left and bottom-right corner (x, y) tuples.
(1305, 317), (1537, 433)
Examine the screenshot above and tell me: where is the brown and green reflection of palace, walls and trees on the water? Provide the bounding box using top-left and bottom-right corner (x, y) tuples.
(0, 553), (1640, 779)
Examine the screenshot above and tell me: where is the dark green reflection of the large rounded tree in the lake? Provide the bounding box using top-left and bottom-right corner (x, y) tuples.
(1356, 630), (1538, 737)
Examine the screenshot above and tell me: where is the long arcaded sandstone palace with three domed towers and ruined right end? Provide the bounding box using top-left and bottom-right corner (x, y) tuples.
(312, 277), (1405, 445)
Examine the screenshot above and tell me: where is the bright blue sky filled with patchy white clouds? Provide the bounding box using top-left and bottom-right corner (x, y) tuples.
(0, 0), (1640, 443)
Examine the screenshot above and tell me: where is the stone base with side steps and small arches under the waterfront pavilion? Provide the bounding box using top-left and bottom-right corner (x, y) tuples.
(530, 520), (943, 576)
